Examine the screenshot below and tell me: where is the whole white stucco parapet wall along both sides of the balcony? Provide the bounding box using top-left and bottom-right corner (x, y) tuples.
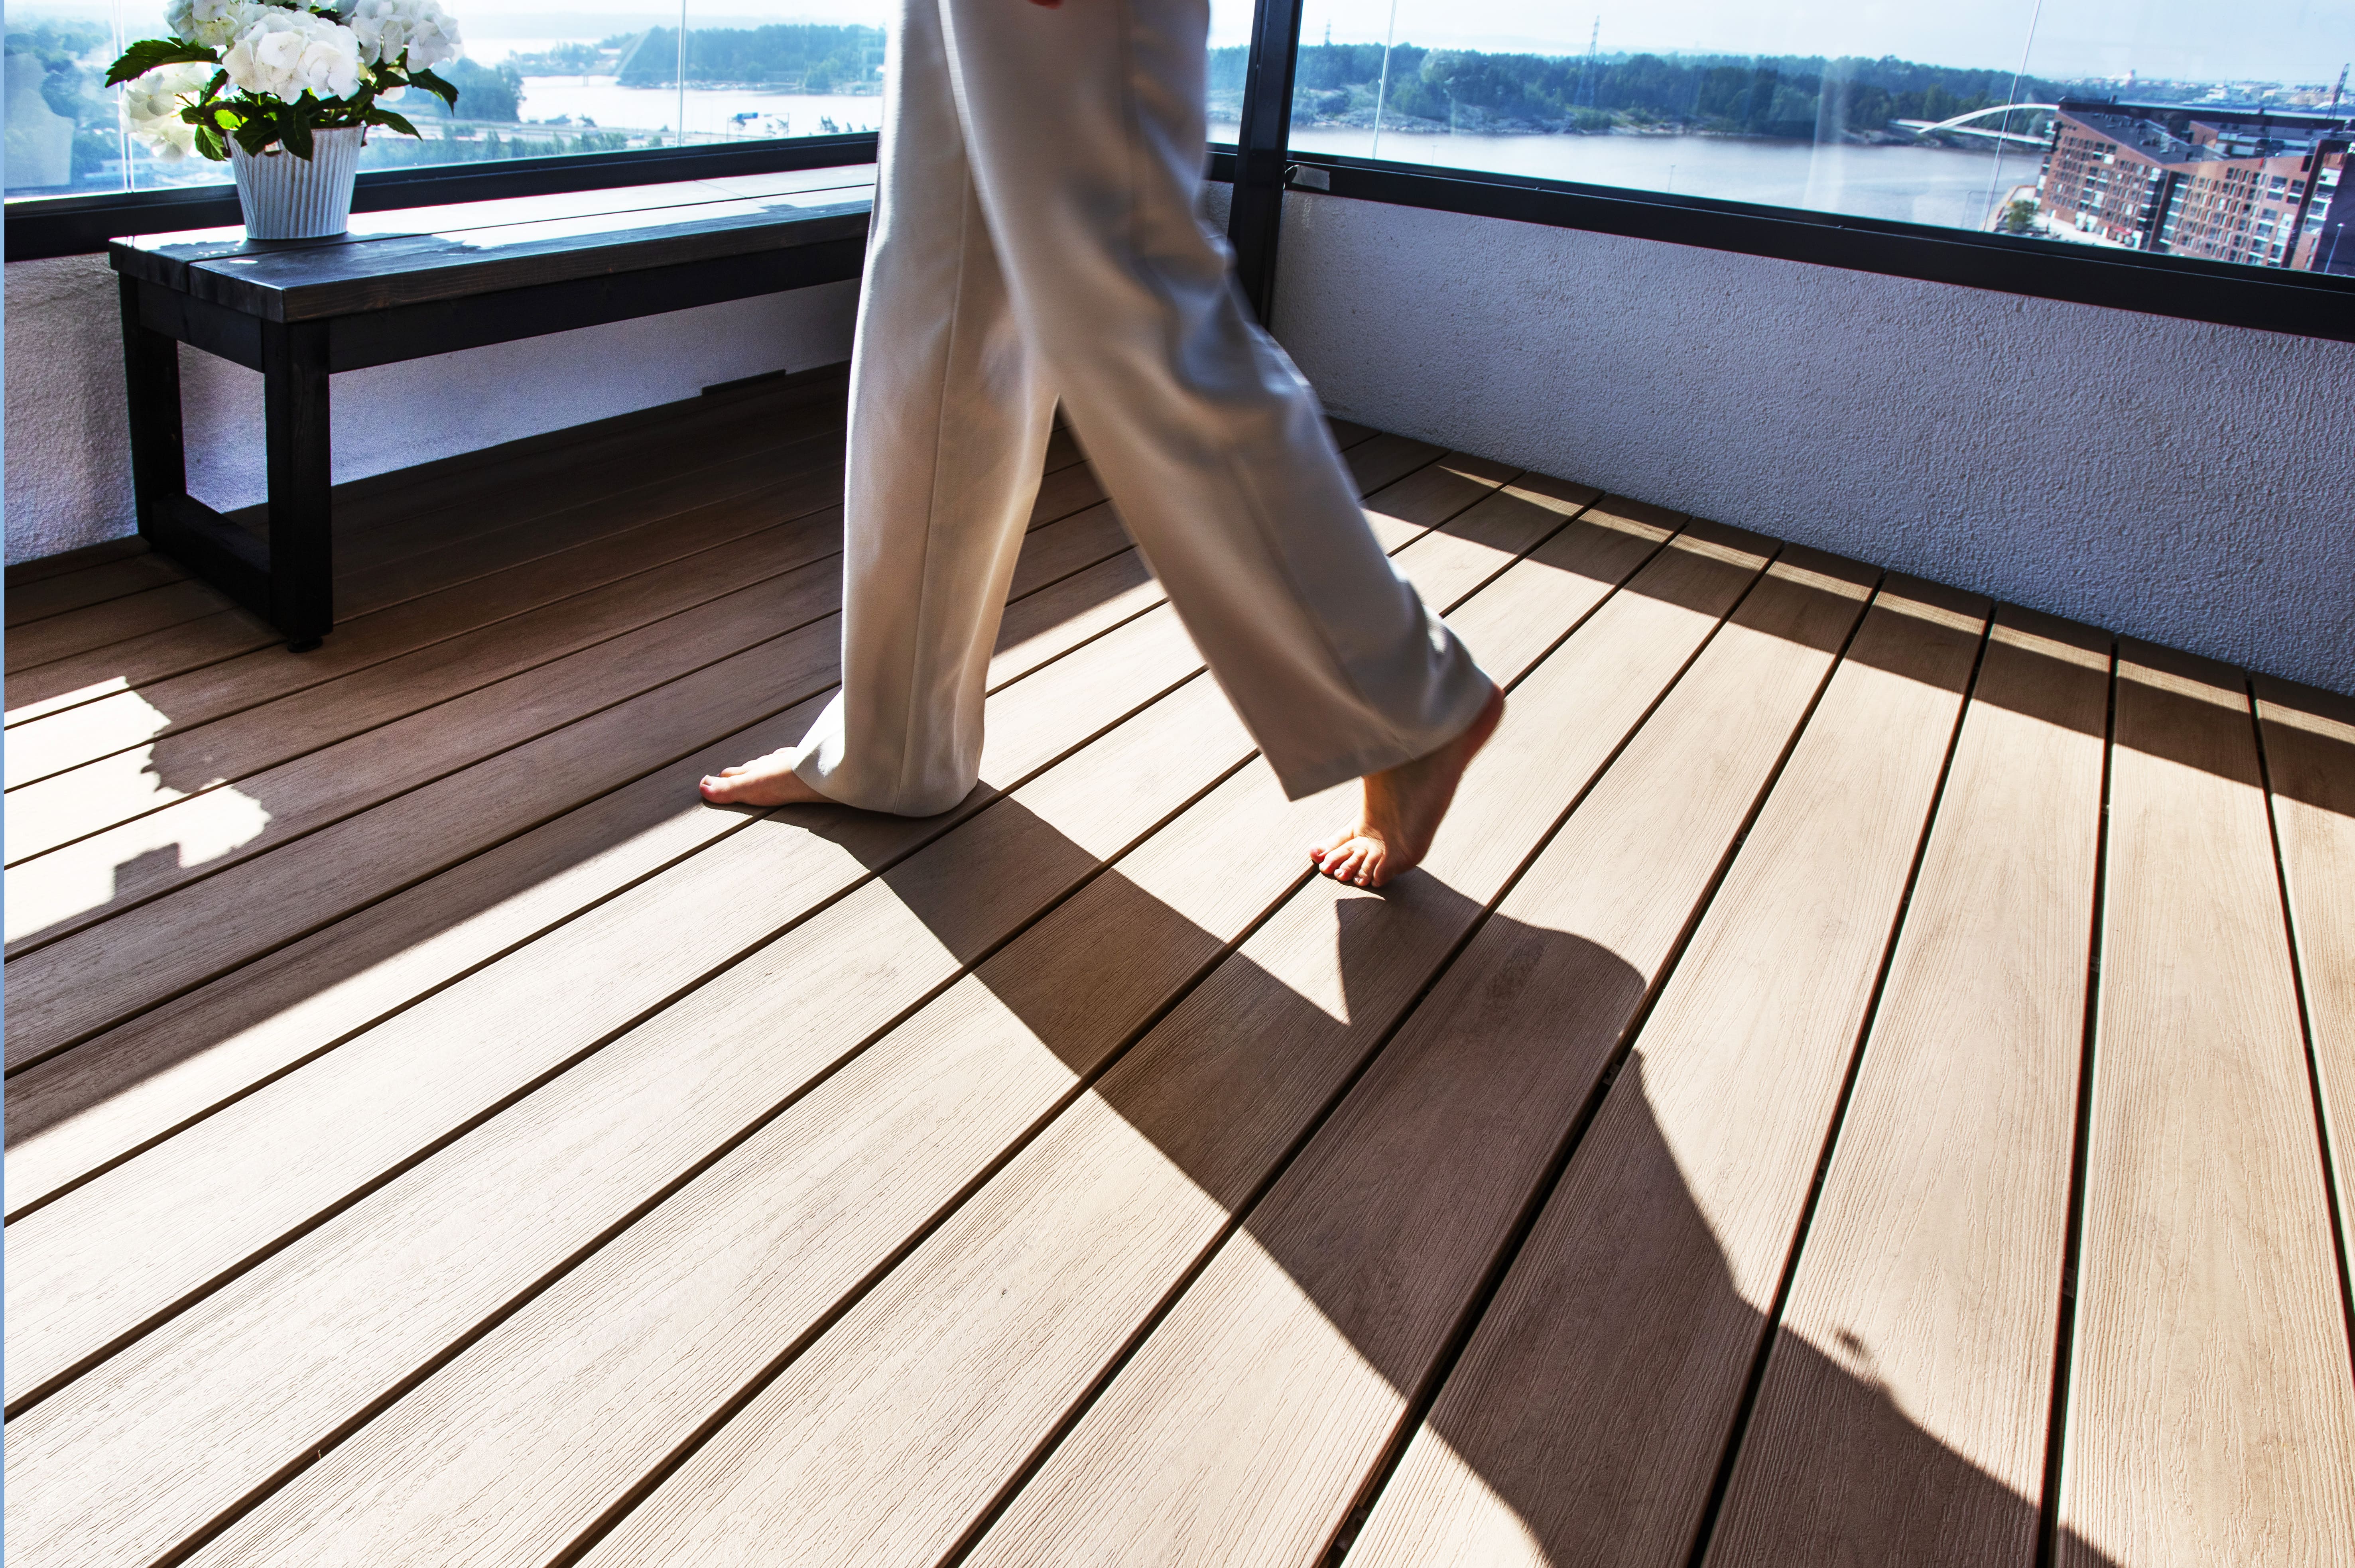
(7, 186), (2355, 692)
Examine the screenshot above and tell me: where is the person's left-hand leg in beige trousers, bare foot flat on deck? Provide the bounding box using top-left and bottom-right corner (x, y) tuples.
(704, 0), (1055, 817)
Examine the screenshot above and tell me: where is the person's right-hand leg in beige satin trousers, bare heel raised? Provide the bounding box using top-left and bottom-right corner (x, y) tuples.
(942, 0), (1500, 883)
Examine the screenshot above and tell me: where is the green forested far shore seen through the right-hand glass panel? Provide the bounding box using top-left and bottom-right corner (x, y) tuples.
(1211, 45), (2061, 139)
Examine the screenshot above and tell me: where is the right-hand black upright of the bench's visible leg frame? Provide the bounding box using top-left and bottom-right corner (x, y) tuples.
(262, 323), (335, 652)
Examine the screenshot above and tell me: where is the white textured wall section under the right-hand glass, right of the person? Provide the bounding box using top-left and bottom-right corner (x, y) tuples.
(1276, 195), (2355, 692)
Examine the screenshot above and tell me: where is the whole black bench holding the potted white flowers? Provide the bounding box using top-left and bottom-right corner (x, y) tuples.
(108, 167), (874, 652)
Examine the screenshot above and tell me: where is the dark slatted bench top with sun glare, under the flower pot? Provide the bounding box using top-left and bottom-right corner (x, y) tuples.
(108, 165), (874, 323)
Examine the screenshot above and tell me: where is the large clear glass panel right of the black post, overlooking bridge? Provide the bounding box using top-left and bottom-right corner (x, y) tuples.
(1290, 0), (2355, 273)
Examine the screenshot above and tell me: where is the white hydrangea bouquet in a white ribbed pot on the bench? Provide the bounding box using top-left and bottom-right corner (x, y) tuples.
(106, 0), (459, 240)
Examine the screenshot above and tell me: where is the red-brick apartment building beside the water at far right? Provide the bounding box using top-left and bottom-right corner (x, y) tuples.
(2037, 101), (2355, 273)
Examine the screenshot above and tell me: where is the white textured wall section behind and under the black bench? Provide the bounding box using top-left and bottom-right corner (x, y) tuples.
(7, 257), (857, 563)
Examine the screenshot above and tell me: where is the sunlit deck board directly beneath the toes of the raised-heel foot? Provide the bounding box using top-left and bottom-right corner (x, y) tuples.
(565, 525), (1764, 1566)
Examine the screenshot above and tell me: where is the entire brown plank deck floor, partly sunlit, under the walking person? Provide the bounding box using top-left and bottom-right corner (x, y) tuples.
(7, 377), (2355, 1568)
